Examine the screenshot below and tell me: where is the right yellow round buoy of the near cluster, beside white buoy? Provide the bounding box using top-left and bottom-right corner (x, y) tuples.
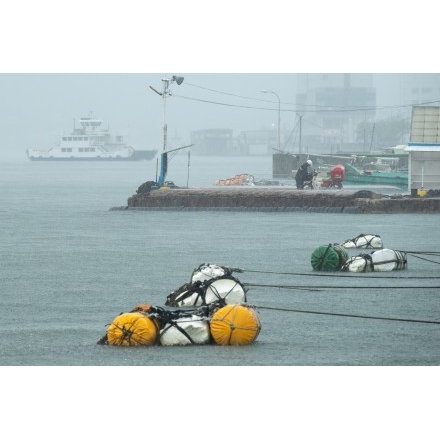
(210, 304), (261, 345)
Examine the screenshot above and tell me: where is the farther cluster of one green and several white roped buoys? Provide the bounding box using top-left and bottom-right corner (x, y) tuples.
(311, 234), (407, 272)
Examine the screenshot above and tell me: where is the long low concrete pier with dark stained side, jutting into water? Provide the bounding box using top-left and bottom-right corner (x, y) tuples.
(111, 186), (440, 214)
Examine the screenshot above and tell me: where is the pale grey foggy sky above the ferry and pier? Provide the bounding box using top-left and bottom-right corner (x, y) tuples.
(0, 72), (422, 157)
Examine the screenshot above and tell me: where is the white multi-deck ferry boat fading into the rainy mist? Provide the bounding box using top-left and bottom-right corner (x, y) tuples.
(26, 113), (157, 161)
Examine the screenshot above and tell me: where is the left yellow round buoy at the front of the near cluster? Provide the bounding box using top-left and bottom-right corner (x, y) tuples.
(107, 312), (159, 346)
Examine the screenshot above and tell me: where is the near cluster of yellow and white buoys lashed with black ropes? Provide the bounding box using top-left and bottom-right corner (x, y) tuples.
(98, 264), (261, 346)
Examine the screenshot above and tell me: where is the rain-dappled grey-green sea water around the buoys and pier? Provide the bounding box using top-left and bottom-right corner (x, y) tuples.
(0, 157), (440, 366)
